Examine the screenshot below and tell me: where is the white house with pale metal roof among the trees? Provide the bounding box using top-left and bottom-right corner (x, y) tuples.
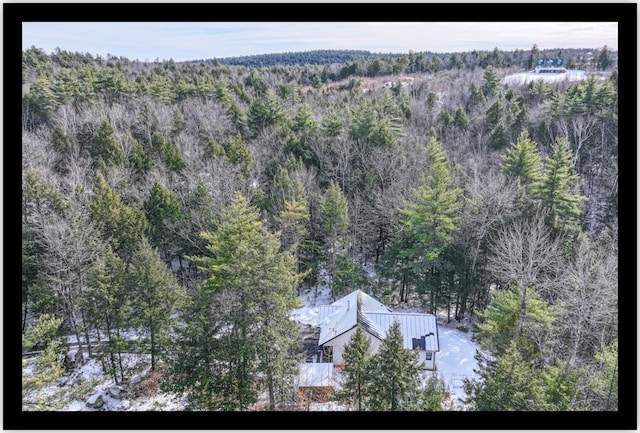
(318, 290), (440, 370)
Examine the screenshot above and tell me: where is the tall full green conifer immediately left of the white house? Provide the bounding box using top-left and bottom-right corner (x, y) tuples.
(175, 193), (300, 410)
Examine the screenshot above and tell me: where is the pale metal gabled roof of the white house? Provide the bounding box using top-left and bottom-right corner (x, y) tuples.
(318, 290), (440, 351)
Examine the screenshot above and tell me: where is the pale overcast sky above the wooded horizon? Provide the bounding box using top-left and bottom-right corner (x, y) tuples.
(22, 22), (618, 61)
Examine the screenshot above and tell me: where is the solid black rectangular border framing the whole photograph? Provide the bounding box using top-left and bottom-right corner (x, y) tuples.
(3, 3), (638, 430)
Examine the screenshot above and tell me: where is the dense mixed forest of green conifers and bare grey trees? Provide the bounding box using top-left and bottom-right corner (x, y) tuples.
(21, 46), (618, 411)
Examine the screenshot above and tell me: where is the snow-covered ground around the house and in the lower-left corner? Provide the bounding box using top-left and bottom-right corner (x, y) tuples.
(22, 266), (476, 411)
